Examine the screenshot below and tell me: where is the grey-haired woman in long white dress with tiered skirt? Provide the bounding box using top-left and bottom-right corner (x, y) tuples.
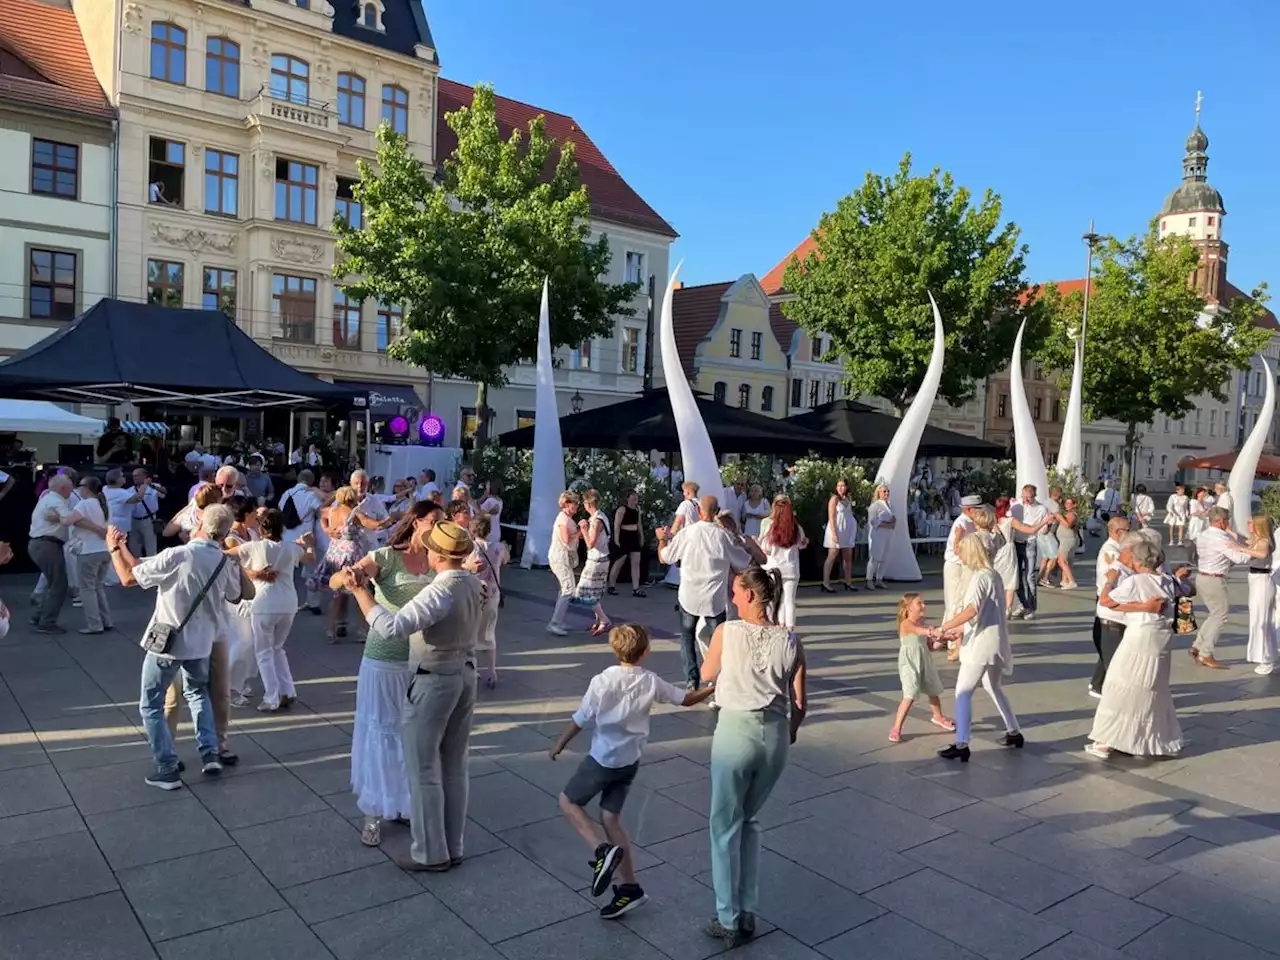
(1084, 541), (1183, 760)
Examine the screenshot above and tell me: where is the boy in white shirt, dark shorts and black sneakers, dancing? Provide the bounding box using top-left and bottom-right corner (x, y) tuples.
(550, 623), (713, 920)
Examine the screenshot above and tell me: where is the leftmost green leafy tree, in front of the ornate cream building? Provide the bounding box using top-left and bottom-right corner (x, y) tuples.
(333, 86), (639, 448)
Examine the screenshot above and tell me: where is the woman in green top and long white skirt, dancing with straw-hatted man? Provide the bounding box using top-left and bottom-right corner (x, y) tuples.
(334, 500), (444, 846)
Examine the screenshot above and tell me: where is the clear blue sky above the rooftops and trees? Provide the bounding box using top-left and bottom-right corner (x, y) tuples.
(424, 0), (1280, 295)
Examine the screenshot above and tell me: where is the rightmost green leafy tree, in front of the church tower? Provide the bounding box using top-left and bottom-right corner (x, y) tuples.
(1039, 221), (1270, 499)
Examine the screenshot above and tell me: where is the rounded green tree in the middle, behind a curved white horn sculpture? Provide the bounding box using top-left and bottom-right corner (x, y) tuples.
(782, 154), (1039, 415)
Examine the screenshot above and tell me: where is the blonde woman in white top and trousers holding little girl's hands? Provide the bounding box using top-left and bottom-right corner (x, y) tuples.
(938, 534), (1024, 763)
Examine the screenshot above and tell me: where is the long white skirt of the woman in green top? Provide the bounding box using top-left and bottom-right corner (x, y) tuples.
(351, 657), (410, 819)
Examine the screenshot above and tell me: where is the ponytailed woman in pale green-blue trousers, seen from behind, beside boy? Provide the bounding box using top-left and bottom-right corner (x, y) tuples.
(701, 566), (805, 946)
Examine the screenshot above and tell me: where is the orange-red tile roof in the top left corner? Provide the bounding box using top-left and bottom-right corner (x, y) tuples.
(0, 0), (115, 119)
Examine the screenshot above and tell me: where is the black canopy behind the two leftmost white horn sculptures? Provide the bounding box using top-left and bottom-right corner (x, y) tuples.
(498, 389), (842, 456)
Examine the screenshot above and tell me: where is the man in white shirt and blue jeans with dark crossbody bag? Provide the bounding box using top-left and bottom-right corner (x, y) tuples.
(108, 503), (241, 790)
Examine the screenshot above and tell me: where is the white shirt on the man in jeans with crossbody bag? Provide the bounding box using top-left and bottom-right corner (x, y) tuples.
(133, 538), (239, 660)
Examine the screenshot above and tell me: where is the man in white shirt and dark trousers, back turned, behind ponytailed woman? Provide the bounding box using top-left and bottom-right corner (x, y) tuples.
(654, 497), (751, 690)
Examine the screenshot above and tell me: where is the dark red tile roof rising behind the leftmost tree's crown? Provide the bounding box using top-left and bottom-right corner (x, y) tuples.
(437, 80), (678, 237)
